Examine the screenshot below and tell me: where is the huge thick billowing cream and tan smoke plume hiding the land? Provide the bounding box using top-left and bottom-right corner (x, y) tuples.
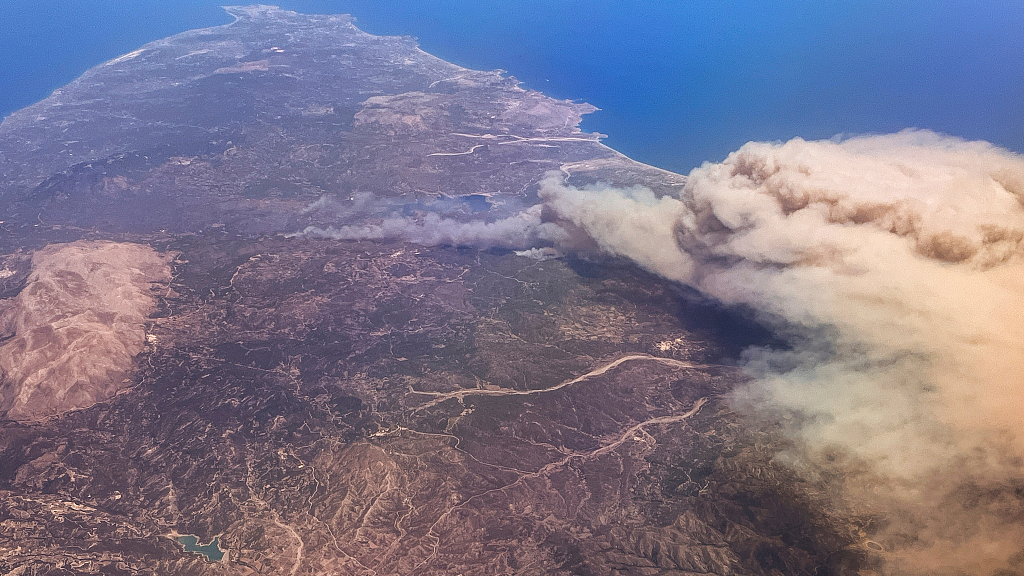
(541, 131), (1024, 574)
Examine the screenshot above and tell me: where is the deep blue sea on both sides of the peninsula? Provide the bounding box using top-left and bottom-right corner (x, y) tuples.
(0, 0), (1024, 172)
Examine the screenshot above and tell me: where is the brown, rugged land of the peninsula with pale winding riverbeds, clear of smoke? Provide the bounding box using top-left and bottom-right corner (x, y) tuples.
(0, 6), (883, 576)
